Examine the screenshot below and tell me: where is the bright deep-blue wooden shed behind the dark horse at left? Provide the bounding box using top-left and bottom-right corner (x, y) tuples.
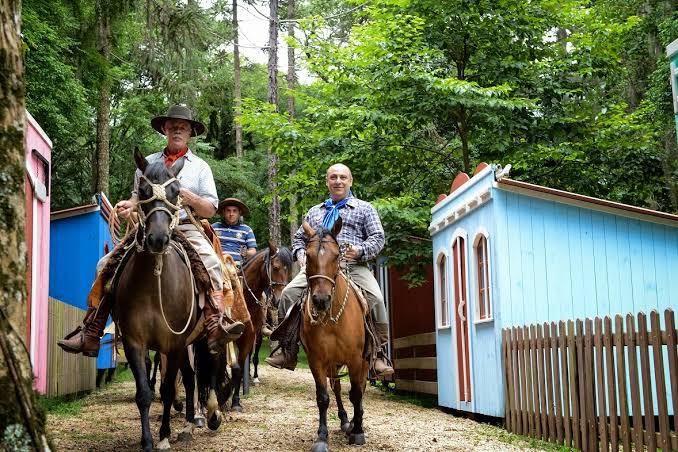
(49, 193), (115, 369)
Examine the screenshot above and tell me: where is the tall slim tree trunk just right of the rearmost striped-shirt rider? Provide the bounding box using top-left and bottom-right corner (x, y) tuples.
(268, 0), (280, 244)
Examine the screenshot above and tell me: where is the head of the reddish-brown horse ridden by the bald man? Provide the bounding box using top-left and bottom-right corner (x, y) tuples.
(303, 217), (342, 312)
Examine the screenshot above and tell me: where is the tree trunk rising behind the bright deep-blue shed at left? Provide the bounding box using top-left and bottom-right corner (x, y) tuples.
(94, 0), (111, 196)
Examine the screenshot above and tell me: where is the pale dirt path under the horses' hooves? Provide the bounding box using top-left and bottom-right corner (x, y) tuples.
(48, 366), (548, 452)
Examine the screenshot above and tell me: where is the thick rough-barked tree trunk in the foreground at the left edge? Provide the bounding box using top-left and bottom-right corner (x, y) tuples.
(0, 0), (48, 450)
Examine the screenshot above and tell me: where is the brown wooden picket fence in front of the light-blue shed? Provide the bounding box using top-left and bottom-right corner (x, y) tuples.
(502, 309), (678, 451)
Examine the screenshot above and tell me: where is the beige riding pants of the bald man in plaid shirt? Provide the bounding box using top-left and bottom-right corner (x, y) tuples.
(278, 265), (388, 323)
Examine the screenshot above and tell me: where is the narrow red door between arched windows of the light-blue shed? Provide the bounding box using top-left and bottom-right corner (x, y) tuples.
(452, 237), (471, 402)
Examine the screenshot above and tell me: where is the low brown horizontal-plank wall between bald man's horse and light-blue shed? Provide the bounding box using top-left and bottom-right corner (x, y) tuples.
(393, 332), (438, 395)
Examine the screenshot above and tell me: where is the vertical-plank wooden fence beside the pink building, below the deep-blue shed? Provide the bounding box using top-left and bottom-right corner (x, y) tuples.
(46, 297), (97, 397)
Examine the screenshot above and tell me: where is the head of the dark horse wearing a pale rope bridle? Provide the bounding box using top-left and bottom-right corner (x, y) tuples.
(134, 148), (184, 254)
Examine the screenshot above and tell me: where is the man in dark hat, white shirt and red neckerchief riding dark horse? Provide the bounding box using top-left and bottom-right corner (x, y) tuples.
(58, 105), (244, 356)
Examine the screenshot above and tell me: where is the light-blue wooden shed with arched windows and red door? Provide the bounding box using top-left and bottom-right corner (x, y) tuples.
(429, 164), (678, 417)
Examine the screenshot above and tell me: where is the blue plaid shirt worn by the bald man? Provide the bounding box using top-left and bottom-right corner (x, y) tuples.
(292, 198), (384, 262)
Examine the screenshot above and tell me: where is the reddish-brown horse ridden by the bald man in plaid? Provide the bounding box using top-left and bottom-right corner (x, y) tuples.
(301, 218), (368, 452)
